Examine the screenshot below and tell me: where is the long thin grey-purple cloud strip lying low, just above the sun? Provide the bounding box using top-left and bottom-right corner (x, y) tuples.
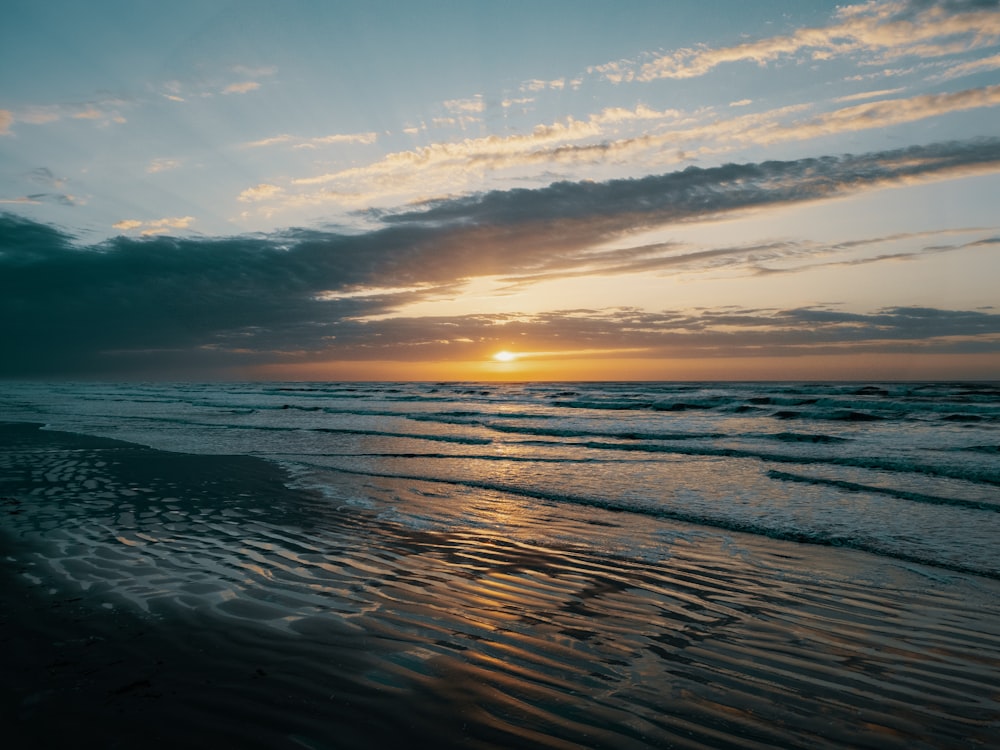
(298, 307), (1000, 361)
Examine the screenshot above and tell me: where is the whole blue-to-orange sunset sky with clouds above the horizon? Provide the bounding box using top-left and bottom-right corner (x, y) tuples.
(0, 0), (1000, 380)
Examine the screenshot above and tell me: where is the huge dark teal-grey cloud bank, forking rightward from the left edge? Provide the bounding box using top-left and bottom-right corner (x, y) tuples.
(0, 139), (1000, 376)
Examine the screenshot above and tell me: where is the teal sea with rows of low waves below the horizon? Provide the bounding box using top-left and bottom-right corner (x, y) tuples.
(0, 383), (1000, 578)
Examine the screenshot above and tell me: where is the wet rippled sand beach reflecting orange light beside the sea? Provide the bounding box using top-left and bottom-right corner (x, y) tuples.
(0, 425), (1000, 748)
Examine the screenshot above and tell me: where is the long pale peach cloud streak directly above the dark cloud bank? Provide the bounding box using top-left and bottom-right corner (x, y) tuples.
(262, 85), (1000, 214)
